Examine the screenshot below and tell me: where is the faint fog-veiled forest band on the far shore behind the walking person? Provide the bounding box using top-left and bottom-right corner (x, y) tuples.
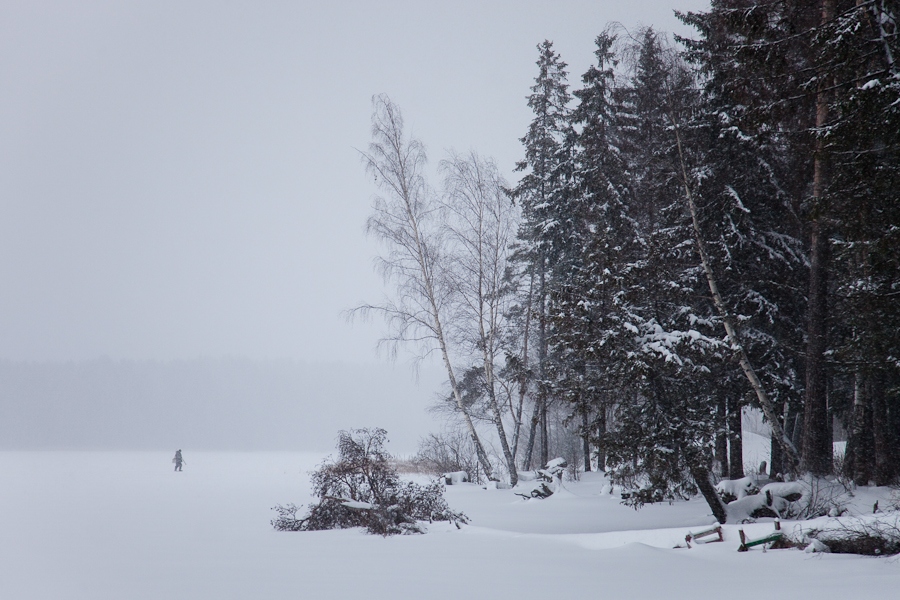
(0, 358), (440, 455)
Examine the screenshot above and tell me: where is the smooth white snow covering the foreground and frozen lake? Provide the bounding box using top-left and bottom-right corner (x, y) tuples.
(0, 448), (900, 600)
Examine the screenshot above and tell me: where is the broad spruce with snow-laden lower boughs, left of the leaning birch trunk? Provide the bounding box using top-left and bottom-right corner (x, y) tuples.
(576, 29), (725, 522)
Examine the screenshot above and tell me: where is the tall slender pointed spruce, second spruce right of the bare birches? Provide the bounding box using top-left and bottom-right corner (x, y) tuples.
(551, 30), (635, 469)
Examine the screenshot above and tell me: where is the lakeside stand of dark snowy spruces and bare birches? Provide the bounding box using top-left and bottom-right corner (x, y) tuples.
(365, 0), (900, 517)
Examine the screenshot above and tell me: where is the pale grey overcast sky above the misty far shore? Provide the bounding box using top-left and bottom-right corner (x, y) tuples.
(0, 0), (708, 362)
